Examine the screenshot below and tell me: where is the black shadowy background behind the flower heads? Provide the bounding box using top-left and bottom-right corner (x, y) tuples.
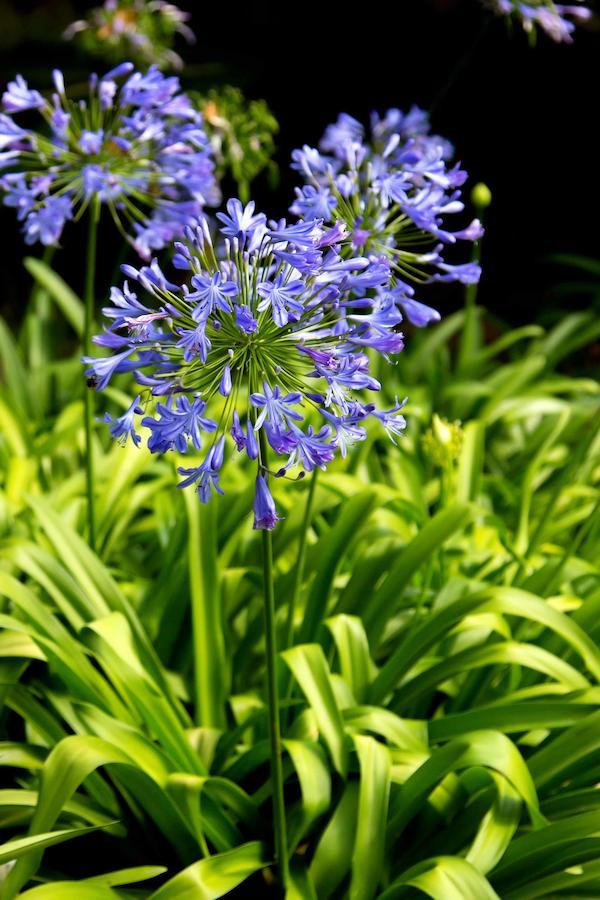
(0, 0), (600, 323)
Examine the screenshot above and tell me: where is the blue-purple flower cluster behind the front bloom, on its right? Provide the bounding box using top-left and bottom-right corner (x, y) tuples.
(291, 107), (483, 320)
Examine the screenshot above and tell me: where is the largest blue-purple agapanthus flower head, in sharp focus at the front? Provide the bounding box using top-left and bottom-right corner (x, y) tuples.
(84, 200), (418, 529)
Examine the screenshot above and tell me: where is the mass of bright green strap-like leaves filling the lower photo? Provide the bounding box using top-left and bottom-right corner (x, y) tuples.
(0, 261), (600, 900)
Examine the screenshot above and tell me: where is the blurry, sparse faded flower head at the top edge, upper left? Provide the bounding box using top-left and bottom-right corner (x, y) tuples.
(64, 0), (195, 69)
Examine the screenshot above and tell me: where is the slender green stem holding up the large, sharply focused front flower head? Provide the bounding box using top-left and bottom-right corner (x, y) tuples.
(259, 429), (290, 891)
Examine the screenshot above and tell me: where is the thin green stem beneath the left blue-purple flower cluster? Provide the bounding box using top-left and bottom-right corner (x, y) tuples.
(83, 203), (99, 550)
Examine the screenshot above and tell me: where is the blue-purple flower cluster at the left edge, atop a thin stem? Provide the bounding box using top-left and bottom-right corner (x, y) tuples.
(0, 63), (219, 258)
